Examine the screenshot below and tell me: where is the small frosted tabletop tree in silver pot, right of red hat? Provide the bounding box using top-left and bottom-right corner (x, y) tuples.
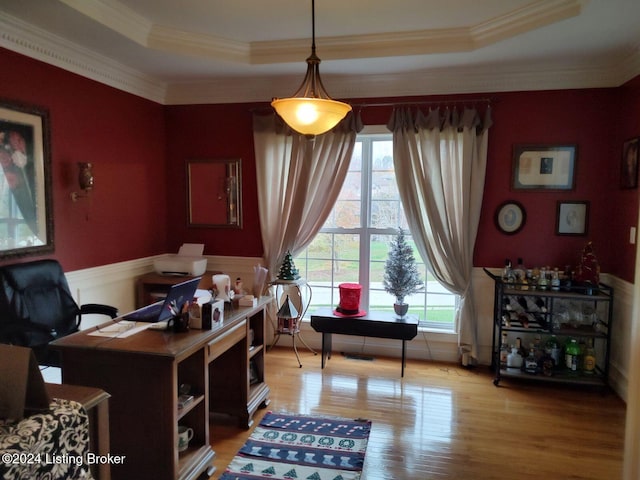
(383, 229), (424, 317)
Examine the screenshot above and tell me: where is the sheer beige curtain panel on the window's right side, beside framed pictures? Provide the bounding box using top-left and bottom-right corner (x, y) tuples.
(388, 107), (491, 358)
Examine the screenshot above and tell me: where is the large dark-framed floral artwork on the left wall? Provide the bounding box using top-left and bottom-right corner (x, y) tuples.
(0, 99), (54, 258)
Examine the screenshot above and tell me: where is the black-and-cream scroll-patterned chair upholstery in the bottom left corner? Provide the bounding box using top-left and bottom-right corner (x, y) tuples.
(0, 398), (93, 480)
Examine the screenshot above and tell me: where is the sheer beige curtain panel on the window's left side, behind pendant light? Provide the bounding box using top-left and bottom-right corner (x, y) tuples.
(253, 113), (362, 279)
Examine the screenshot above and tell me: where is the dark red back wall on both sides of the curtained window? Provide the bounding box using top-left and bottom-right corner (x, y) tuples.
(167, 88), (640, 281)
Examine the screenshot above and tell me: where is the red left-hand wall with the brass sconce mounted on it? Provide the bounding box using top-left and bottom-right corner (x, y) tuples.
(0, 49), (168, 270)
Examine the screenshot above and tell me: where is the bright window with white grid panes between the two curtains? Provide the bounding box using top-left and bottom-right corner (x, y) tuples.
(294, 128), (457, 331)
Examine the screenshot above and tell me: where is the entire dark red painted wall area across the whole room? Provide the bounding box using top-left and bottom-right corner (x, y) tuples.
(0, 49), (640, 281)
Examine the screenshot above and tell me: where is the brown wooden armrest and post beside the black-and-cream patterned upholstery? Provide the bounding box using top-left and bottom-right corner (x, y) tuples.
(46, 383), (111, 480)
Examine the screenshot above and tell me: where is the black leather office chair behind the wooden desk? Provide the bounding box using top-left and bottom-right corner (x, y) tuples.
(0, 260), (118, 367)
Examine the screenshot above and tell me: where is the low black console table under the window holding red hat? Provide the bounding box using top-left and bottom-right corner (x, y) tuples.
(311, 307), (418, 377)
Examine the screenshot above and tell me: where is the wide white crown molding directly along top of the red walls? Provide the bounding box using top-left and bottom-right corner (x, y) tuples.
(0, 6), (640, 105)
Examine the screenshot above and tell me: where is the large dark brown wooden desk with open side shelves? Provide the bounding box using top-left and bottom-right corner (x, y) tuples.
(52, 297), (271, 480)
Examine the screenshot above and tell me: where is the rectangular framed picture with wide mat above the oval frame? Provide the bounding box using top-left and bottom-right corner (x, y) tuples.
(512, 145), (576, 190)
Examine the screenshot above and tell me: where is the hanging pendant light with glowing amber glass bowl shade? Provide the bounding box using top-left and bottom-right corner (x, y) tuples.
(271, 0), (351, 137)
